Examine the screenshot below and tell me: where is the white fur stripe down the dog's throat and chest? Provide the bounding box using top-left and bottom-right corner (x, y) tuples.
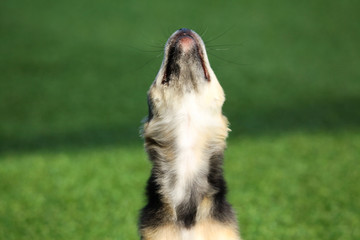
(162, 94), (223, 207)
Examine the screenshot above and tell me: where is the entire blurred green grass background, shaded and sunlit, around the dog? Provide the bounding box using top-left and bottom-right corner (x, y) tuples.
(0, 0), (360, 239)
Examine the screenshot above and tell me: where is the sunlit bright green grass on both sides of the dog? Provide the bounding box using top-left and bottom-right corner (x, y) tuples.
(0, 133), (360, 239)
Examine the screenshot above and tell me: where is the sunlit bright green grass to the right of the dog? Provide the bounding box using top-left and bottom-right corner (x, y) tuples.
(226, 133), (360, 239)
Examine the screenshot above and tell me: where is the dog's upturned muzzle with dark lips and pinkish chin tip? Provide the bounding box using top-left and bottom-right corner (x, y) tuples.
(161, 28), (210, 85)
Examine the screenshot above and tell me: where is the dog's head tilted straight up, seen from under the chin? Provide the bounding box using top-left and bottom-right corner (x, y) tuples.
(148, 28), (225, 121)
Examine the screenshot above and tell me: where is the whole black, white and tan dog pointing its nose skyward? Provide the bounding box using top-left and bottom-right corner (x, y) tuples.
(139, 28), (240, 240)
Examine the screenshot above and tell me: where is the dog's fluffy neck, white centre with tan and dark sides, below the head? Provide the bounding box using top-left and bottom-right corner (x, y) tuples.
(144, 93), (228, 226)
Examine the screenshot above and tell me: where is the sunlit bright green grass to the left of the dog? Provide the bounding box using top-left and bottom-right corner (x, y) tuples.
(0, 148), (148, 239)
